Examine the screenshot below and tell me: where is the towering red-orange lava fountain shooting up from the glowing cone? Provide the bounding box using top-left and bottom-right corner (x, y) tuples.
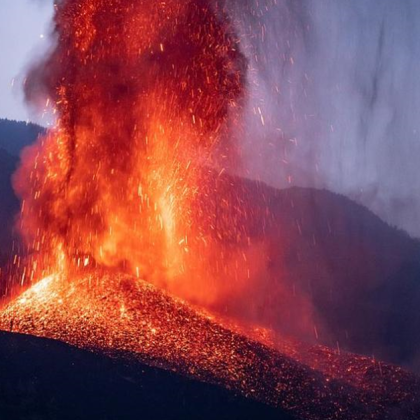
(15, 0), (246, 298)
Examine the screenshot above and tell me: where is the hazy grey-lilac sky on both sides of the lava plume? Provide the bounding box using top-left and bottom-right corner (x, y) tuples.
(0, 0), (420, 237)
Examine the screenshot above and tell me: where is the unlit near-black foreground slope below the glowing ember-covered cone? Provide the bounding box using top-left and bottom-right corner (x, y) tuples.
(0, 332), (292, 420)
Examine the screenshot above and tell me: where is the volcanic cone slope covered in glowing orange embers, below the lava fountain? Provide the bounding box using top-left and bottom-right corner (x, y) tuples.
(0, 270), (420, 420)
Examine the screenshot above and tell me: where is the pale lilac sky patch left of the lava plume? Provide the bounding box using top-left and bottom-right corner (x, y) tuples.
(0, 0), (52, 120)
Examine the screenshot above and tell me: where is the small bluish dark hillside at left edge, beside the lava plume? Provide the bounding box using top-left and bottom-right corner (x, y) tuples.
(0, 119), (45, 157)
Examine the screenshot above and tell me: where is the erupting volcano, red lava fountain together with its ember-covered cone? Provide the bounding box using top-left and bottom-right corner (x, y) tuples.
(0, 0), (420, 420)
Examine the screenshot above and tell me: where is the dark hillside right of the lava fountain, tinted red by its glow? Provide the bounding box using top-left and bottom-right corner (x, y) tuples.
(196, 177), (420, 369)
